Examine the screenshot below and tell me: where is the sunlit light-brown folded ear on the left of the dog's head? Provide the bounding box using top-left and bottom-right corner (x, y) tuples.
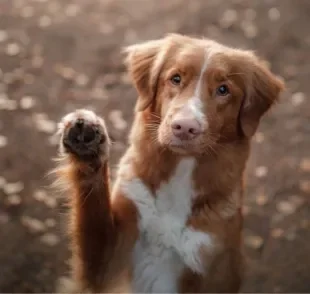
(123, 39), (167, 111)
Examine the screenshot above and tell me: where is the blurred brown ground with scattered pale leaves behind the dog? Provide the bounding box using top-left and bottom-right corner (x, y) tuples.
(0, 0), (310, 293)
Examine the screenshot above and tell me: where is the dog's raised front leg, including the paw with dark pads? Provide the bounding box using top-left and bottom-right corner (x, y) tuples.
(58, 110), (137, 292)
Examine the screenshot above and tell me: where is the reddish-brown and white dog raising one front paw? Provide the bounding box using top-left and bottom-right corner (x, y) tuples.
(57, 34), (284, 293)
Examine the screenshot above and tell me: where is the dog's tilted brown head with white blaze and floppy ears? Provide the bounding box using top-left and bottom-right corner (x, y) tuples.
(125, 34), (284, 154)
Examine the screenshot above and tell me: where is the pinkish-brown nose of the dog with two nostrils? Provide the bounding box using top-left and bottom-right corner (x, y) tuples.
(171, 118), (202, 140)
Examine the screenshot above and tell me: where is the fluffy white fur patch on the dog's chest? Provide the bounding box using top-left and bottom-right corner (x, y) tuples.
(122, 158), (213, 293)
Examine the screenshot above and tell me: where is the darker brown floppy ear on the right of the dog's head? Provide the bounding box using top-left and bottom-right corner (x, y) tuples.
(240, 55), (284, 138)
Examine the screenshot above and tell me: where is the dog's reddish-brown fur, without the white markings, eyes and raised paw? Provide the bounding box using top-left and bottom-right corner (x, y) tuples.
(54, 34), (283, 292)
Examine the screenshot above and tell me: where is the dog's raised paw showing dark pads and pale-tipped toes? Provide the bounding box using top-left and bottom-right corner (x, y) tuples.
(59, 109), (109, 160)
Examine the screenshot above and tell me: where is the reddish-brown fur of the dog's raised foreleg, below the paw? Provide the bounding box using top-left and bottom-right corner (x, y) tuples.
(56, 155), (137, 292)
